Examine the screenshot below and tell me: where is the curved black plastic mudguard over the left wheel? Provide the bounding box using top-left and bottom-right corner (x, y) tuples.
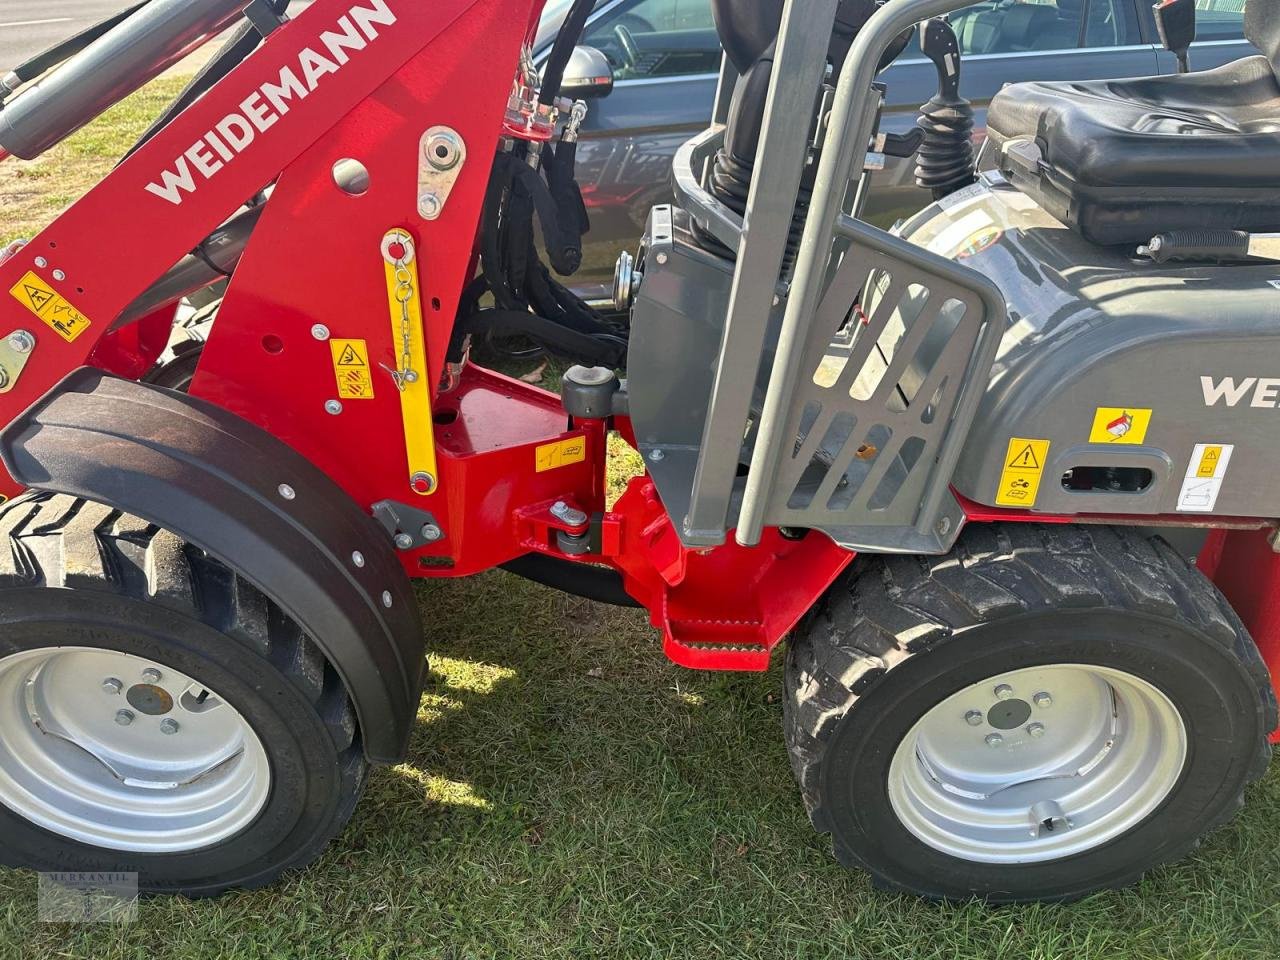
(0, 367), (426, 763)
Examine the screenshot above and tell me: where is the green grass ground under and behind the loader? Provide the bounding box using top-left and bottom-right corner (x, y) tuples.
(0, 81), (1280, 960)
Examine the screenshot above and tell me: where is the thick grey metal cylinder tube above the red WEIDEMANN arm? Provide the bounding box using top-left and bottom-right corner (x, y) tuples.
(0, 0), (246, 160)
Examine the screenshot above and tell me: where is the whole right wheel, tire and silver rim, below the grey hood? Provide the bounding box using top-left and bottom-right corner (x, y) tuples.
(785, 525), (1277, 902)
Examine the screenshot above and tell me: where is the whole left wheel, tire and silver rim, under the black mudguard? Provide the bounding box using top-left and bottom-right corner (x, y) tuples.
(0, 494), (367, 896)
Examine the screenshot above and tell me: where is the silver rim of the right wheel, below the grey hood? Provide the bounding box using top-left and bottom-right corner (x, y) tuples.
(888, 663), (1187, 863)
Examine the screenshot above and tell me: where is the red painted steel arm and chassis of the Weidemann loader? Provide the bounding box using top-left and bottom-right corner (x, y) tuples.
(0, 0), (1280, 737)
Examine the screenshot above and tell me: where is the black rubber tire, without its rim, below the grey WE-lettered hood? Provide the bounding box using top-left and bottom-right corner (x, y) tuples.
(785, 524), (1277, 902)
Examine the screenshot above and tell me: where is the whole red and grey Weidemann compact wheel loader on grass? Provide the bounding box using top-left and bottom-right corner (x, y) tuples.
(0, 0), (1280, 901)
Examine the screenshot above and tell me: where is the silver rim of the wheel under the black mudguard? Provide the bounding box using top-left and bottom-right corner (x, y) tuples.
(0, 646), (270, 854)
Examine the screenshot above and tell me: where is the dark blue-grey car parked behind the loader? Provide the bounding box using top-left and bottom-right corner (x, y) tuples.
(535, 0), (1248, 298)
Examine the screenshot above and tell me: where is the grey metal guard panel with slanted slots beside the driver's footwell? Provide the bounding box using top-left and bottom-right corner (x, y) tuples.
(765, 218), (1004, 552)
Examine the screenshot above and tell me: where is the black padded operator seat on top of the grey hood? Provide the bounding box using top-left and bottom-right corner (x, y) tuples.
(987, 0), (1280, 244)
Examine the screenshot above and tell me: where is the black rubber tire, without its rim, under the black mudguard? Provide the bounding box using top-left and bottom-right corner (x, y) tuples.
(0, 494), (367, 896)
